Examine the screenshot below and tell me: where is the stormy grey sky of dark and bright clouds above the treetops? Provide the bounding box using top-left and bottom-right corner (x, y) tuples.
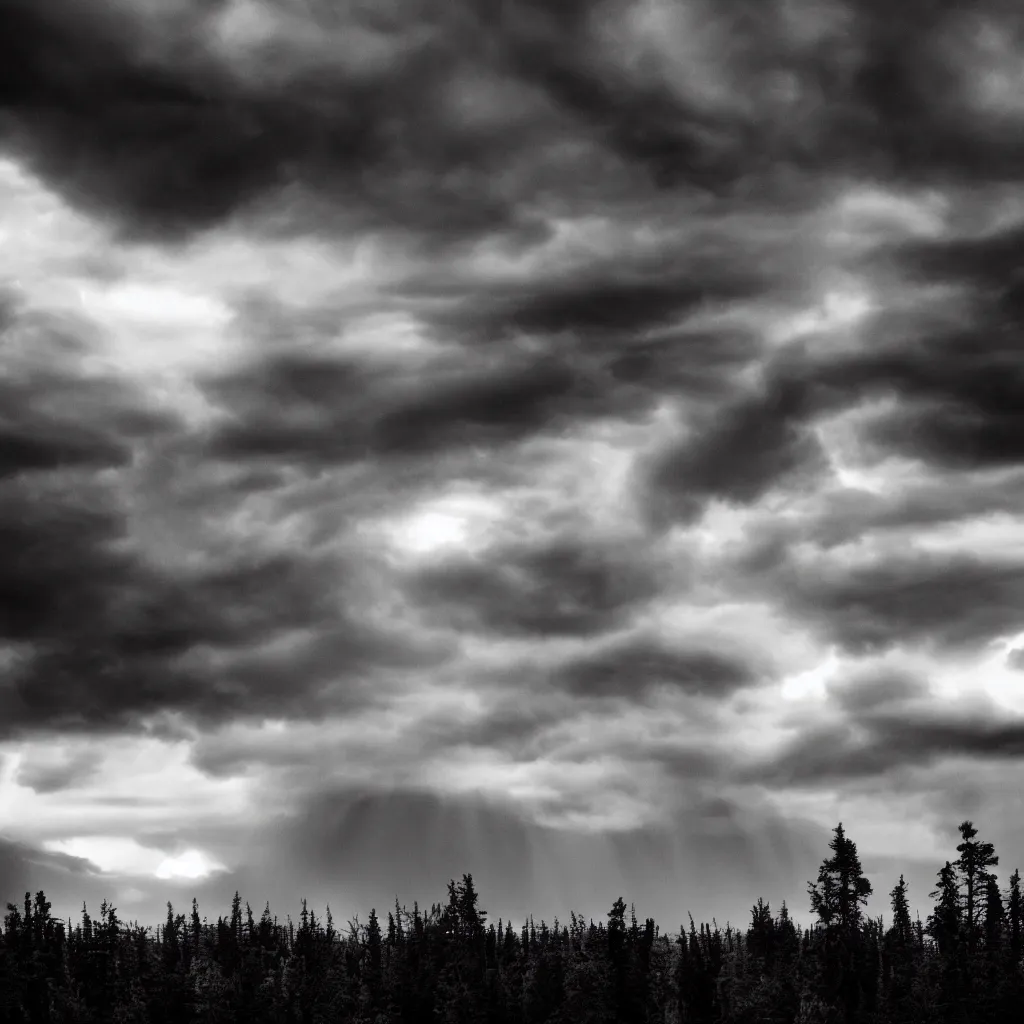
(0, 0), (1024, 931)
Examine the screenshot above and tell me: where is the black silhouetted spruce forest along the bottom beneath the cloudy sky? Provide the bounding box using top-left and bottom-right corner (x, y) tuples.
(0, 821), (1024, 1024)
